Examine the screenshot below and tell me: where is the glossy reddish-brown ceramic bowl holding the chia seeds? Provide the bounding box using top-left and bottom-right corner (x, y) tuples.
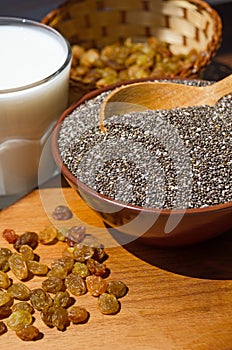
(52, 83), (232, 247)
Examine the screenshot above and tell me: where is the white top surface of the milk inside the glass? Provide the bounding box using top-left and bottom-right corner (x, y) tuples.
(0, 25), (67, 90)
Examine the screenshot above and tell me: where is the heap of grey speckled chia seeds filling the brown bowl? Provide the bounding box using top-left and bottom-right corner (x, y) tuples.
(58, 80), (232, 209)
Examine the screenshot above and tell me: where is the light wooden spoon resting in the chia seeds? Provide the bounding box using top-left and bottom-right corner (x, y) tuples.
(100, 74), (232, 132)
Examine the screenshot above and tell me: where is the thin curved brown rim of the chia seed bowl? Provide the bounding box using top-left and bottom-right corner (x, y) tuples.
(51, 77), (232, 215)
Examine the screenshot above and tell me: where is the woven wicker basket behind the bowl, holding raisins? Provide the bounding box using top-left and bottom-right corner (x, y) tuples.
(42, 0), (222, 100)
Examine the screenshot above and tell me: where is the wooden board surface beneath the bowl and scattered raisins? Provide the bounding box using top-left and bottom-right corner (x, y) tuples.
(0, 188), (232, 350)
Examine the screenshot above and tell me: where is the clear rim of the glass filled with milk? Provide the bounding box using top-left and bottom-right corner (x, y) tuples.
(0, 16), (72, 96)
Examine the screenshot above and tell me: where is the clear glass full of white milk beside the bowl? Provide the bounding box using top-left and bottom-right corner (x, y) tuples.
(0, 17), (72, 208)
